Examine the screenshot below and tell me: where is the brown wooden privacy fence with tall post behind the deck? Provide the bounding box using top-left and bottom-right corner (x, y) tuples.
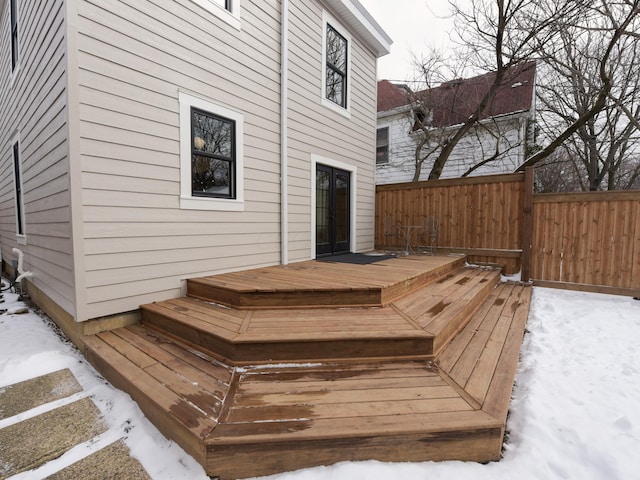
(375, 169), (640, 296)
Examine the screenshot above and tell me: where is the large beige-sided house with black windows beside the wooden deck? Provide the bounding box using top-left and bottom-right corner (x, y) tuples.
(0, 0), (391, 338)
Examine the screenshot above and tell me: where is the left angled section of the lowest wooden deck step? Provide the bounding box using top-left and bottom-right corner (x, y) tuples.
(84, 325), (233, 465)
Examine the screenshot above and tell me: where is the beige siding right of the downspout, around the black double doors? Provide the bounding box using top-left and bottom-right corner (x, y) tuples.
(289, 2), (376, 261)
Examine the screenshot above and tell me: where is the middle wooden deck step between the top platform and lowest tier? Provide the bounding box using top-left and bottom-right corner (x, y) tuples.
(141, 267), (500, 365)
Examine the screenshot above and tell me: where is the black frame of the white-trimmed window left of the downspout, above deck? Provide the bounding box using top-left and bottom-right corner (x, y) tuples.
(189, 106), (237, 200)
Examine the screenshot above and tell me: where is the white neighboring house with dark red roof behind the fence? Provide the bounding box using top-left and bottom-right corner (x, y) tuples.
(376, 63), (536, 184)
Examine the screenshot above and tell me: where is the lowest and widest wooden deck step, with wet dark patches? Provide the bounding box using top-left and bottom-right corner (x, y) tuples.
(85, 279), (531, 480)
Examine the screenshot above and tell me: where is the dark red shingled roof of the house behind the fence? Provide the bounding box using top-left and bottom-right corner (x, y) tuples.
(378, 62), (536, 127)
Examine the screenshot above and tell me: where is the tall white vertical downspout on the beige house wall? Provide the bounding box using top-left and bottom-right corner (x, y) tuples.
(280, 0), (289, 265)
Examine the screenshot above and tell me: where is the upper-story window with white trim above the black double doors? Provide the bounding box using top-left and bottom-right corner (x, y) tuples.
(322, 13), (351, 116)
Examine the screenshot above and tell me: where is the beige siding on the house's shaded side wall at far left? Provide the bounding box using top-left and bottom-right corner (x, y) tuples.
(0, 0), (75, 315)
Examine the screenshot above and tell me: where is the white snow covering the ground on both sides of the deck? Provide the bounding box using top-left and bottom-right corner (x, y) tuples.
(0, 288), (640, 480)
